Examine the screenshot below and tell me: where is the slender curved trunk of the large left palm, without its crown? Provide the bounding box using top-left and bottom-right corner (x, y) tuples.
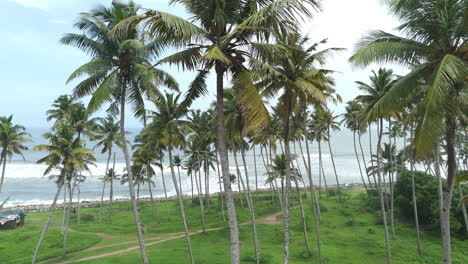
(120, 84), (148, 264)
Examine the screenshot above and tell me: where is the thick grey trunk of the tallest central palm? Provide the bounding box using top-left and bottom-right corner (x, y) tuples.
(216, 63), (240, 264)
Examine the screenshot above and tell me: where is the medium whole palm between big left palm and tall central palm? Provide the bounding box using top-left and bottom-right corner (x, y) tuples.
(142, 93), (195, 264)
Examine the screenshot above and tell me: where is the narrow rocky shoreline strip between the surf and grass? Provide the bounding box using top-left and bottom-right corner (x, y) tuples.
(0, 183), (364, 214)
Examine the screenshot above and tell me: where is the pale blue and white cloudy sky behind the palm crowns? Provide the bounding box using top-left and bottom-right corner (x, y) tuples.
(0, 0), (405, 128)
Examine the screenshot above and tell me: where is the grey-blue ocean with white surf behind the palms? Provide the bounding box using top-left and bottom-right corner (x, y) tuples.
(0, 128), (388, 207)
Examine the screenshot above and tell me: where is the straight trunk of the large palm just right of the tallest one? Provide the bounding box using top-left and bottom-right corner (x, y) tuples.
(283, 90), (292, 264)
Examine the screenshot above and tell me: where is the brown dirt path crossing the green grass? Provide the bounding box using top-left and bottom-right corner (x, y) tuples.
(48, 212), (283, 264)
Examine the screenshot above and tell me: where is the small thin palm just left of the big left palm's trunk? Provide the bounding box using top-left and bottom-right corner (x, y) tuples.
(94, 115), (122, 224)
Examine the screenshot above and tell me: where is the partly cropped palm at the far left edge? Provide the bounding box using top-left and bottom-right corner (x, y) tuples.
(0, 115), (31, 192)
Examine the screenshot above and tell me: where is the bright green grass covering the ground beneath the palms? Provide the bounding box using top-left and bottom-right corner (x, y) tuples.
(0, 190), (468, 264)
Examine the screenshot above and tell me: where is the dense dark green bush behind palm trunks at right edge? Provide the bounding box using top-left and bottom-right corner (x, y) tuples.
(395, 170), (468, 233)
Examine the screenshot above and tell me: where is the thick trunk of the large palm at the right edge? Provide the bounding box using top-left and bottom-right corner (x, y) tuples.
(436, 116), (457, 264)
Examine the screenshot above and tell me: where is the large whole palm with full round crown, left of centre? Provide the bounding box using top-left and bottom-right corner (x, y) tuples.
(61, 1), (177, 264)
